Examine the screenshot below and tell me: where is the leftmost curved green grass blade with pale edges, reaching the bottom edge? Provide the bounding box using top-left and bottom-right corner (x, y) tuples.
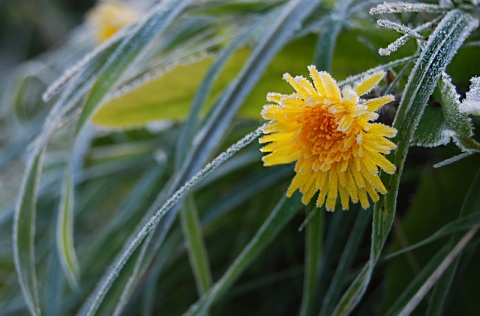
(13, 150), (44, 315)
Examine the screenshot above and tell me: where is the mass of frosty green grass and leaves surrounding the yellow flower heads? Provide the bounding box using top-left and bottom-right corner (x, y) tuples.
(0, 0), (480, 315)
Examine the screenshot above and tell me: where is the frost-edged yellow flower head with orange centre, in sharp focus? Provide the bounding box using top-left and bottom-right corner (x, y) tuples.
(260, 66), (397, 211)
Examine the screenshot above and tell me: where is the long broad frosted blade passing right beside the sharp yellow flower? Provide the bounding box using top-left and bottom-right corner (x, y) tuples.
(335, 10), (478, 315)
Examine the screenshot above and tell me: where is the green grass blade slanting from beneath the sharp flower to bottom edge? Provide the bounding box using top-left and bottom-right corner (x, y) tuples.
(184, 193), (303, 316)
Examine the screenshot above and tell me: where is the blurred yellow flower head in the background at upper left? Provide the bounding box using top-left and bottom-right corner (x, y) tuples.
(87, 2), (140, 43)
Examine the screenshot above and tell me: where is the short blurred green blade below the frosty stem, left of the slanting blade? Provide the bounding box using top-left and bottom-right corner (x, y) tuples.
(180, 196), (212, 296)
